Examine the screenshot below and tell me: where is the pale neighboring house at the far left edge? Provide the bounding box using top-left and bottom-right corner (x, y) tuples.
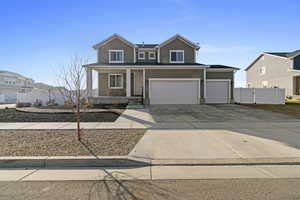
(0, 70), (34, 103)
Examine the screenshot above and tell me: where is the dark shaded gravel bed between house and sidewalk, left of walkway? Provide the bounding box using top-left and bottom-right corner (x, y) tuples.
(0, 109), (120, 122)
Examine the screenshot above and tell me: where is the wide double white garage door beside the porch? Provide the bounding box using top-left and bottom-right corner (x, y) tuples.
(149, 79), (200, 104)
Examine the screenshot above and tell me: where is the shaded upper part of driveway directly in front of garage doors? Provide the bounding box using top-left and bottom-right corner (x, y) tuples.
(149, 104), (295, 123)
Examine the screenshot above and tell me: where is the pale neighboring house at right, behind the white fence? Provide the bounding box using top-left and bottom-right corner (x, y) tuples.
(245, 50), (300, 96)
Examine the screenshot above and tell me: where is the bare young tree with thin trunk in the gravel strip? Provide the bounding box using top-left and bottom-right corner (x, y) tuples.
(57, 56), (87, 141)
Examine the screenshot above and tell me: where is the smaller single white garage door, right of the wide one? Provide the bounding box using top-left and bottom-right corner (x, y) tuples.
(205, 80), (230, 103)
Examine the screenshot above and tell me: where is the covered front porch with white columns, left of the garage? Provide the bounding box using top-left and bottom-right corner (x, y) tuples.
(87, 68), (145, 105)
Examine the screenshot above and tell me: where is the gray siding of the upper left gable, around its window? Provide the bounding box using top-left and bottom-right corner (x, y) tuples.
(98, 38), (134, 64)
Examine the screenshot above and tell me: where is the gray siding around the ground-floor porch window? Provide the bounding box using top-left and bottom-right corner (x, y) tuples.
(98, 72), (126, 96)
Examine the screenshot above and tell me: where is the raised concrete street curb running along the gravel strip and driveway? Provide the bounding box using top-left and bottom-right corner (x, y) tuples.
(0, 156), (300, 169)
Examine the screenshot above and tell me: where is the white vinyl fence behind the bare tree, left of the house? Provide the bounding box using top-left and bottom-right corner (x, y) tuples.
(17, 89), (65, 105)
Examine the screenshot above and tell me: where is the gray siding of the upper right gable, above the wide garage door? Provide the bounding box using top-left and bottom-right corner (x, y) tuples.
(160, 39), (195, 63)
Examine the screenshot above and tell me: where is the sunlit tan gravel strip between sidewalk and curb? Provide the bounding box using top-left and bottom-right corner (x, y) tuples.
(0, 130), (145, 156)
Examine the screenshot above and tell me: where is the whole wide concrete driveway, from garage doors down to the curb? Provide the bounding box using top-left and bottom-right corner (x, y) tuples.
(130, 104), (300, 163)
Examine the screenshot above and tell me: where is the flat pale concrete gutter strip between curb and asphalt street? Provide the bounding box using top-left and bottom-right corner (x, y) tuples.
(0, 166), (300, 181)
